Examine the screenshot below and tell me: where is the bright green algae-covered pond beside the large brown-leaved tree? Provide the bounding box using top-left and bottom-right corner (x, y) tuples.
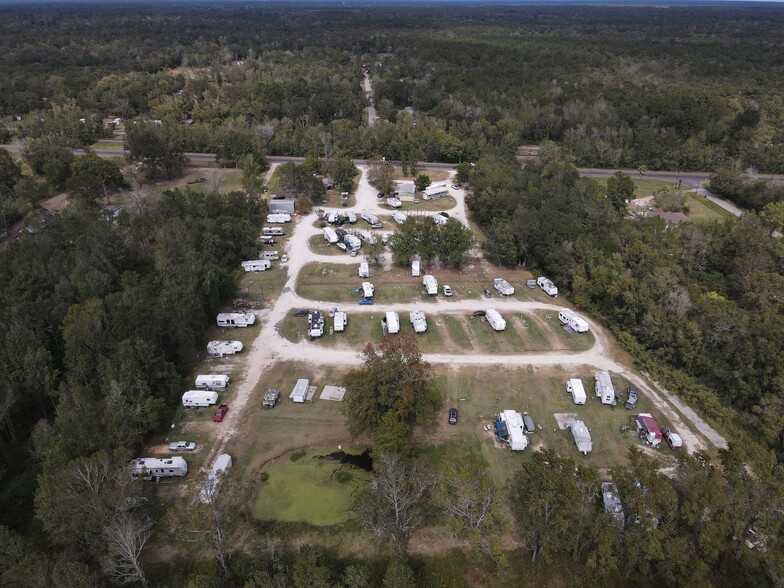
(253, 452), (370, 526)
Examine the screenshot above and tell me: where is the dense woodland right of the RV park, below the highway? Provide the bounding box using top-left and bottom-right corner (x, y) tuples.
(467, 149), (784, 452)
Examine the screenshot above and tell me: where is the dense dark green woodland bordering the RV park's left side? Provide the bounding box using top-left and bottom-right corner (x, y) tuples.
(0, 190), (266, 564)
